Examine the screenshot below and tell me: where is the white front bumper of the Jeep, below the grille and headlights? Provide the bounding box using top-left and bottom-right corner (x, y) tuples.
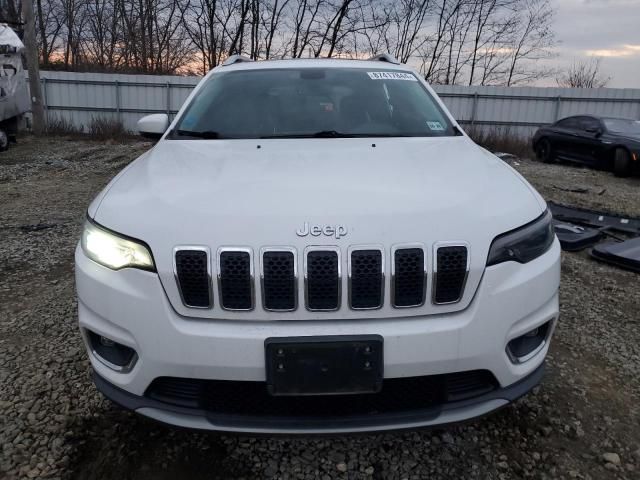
(76, 240), (560, 433)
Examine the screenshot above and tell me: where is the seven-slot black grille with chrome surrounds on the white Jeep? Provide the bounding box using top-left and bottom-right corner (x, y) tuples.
(174, 242), (469, 312)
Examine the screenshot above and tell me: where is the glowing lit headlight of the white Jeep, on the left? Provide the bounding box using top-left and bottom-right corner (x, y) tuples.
(80, 220), (155, 271)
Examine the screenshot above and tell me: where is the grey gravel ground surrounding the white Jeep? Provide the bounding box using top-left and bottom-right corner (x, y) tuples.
(0, 138), (640, 480)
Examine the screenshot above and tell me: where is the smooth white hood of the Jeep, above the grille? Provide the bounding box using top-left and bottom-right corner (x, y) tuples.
(90, 137), (544, 318)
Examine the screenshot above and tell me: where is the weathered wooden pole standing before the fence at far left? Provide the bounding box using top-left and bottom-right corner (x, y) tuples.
(22, 0), (47, 135)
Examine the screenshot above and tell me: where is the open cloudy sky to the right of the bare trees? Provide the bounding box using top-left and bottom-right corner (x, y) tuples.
(545, 0), (640, 88)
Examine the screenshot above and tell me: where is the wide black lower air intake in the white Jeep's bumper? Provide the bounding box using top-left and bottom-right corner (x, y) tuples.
(145, 370), (498, 419)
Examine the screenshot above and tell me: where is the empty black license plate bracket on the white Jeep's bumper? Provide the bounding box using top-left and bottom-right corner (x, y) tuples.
(265, 335), (383, 395)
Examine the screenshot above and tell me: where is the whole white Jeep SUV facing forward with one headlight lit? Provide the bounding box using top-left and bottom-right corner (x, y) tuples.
(76, 55), (560, 434)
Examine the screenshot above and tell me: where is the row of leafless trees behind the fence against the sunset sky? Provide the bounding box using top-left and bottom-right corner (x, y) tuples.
(28, 0), (554, 85)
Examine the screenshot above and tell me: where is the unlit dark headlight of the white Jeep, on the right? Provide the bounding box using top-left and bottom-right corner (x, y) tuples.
(487, 210), (555, 266)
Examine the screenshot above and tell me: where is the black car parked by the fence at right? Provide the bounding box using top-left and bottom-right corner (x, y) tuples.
(533, 115), (640, 177)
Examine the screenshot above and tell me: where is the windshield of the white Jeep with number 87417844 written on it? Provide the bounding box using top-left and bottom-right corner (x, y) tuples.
(170, 68), (456, 139)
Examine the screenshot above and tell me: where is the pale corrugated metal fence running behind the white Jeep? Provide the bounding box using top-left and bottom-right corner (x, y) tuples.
(40, 72), (640, 137)
